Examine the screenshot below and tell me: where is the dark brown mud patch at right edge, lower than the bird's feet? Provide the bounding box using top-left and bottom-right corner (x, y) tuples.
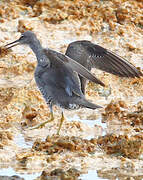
(97, 134), (143, 159)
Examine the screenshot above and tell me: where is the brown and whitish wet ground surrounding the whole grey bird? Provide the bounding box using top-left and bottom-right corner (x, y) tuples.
(0, 0), (143, 180)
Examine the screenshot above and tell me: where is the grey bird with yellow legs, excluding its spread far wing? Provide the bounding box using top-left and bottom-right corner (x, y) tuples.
(6, 31), (104, 134)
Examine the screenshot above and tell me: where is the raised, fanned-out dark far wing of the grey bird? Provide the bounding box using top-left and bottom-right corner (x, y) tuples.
(65, 40), (143, 93)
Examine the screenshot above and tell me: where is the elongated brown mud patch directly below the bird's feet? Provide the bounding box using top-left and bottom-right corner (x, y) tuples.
(32, 136), (96, 155)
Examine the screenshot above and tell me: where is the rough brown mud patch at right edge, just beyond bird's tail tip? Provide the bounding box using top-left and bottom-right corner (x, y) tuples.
(102, 100), (143, 135)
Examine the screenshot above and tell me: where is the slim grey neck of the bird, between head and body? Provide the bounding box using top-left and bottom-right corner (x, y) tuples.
(30, 39), (49, 66)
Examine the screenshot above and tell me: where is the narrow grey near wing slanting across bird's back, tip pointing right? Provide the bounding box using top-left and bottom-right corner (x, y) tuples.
(45, 50), (105, 86)
